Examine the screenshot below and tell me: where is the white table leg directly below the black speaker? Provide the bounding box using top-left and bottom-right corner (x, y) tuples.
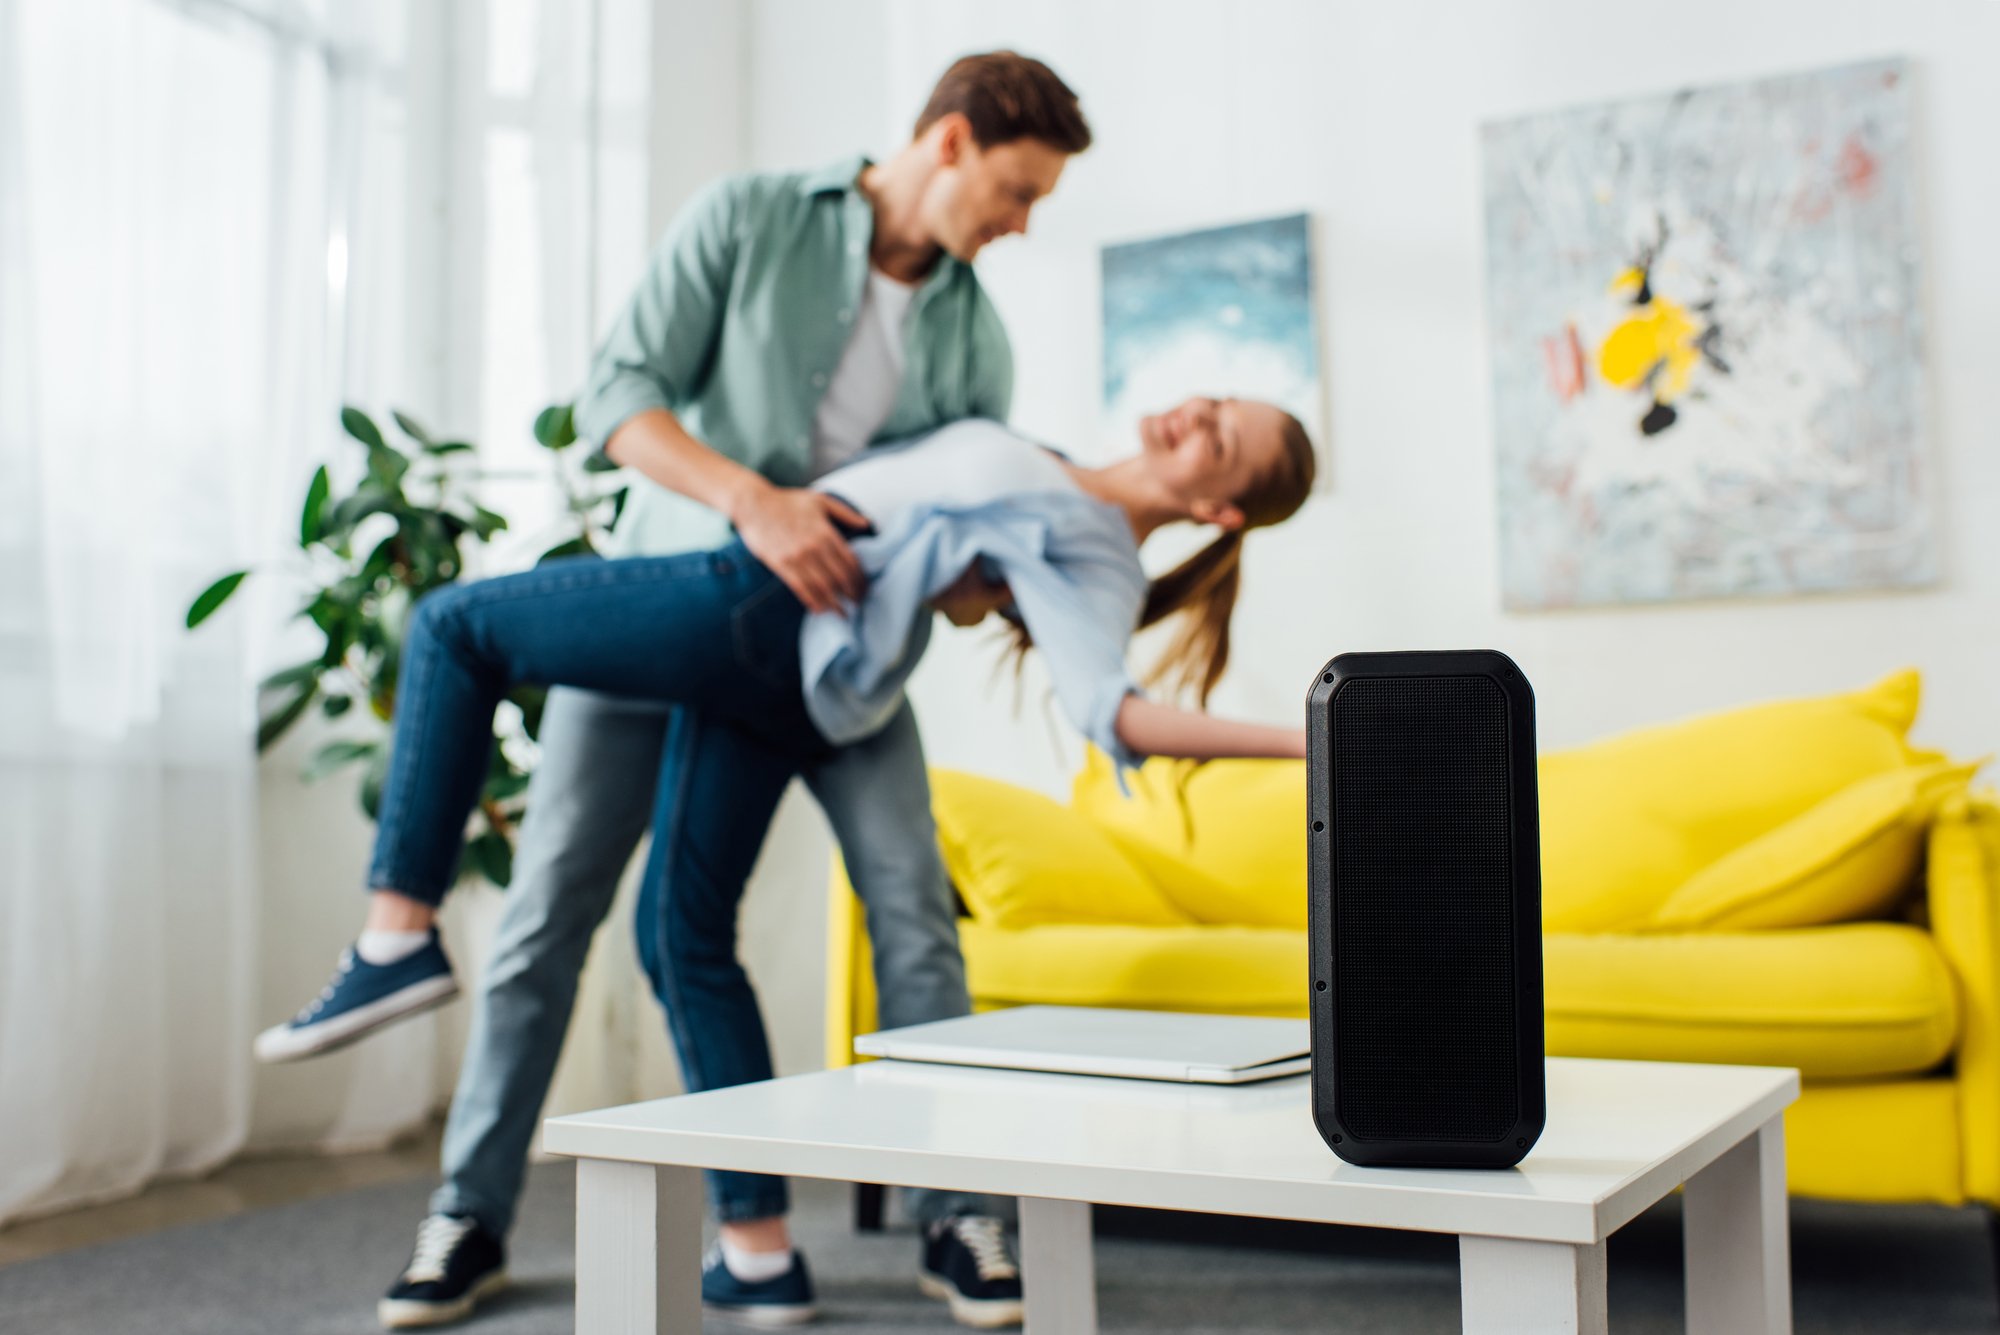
(1458, 1233), (1606, 1335)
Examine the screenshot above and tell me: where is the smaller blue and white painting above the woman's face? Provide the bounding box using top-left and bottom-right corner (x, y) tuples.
(1104, 214), (1324, 476)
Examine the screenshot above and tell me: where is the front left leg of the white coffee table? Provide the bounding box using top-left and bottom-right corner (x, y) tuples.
(576, 1159), (702, 1335)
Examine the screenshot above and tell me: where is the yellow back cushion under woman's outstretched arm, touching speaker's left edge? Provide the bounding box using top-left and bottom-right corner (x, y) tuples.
(1070, 747), (1306, 929)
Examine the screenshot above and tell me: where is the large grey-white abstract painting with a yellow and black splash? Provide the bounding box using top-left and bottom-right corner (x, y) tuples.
(1484, 60), (1938, 610)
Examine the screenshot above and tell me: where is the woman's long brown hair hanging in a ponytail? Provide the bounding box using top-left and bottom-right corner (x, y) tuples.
(1008, 414), (1314, 707)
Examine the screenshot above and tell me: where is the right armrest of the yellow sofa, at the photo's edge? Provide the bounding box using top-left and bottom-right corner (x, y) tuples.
(1926, 793), (2000, 1203)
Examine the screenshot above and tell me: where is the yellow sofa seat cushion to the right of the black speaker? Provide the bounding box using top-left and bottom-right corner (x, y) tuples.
(1542, 923), (1958, 1079)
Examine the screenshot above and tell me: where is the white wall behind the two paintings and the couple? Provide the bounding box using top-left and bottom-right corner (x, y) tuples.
(716, 0), (2000, 1063)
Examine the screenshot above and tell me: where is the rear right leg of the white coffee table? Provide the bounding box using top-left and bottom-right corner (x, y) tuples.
(1682, 1117), (1792, 1335)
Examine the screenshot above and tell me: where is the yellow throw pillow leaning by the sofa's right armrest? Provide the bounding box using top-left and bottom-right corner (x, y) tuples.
(1648, 761), (1978, 931)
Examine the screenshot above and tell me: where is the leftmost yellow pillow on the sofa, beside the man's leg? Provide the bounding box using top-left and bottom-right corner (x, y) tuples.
(930, 769), (1188, 927)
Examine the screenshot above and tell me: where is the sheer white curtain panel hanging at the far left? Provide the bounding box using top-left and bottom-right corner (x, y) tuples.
(0, 0), (316, 1217)
